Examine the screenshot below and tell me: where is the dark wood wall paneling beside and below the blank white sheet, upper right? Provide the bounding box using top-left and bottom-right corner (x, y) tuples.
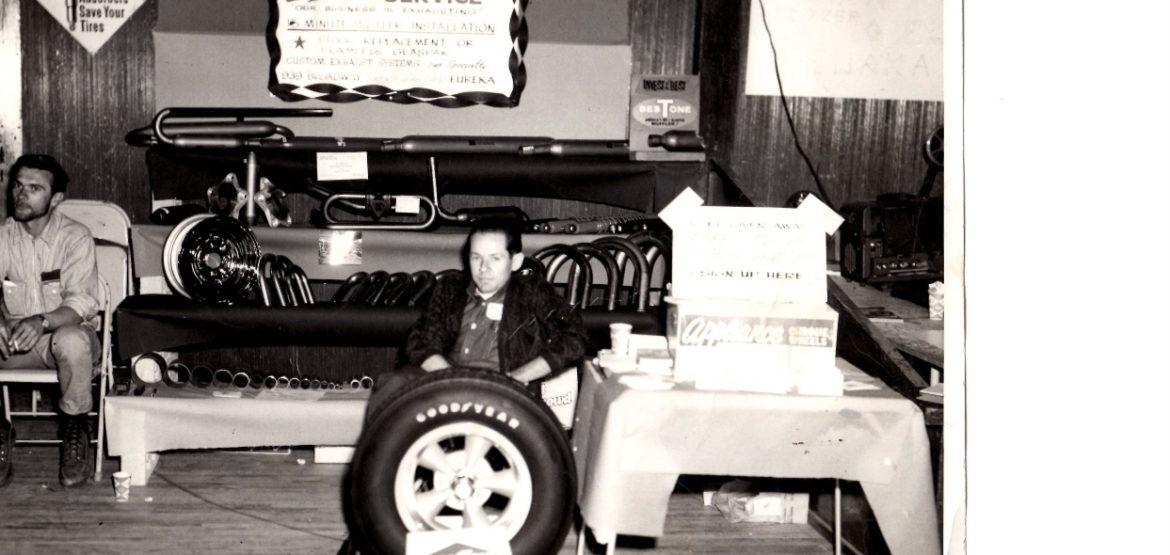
(700, 0), (943, 206)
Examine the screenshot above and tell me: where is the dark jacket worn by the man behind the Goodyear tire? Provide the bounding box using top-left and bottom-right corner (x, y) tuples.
(406, 272), (586, 384)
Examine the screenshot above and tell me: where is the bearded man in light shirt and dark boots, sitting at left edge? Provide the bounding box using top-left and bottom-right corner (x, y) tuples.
(0, 155), (101, 487)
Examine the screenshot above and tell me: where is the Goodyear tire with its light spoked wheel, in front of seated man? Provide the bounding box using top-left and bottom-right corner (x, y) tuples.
(345, 370), (577, 555)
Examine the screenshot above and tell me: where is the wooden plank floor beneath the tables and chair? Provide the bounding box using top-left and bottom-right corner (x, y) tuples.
(0, 445), (832, 555)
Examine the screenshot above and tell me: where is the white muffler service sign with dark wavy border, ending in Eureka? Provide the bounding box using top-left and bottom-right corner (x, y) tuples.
(267, 0), (528, 108)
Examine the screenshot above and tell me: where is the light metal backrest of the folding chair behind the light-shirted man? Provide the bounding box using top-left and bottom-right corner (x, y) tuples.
(57, 199), (133, 308)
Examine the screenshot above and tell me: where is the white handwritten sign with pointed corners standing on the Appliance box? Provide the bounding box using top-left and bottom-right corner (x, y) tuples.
(659, 191), (840, 303)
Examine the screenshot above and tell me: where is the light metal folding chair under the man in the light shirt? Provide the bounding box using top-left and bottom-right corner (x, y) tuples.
(0, 199), (131, 481)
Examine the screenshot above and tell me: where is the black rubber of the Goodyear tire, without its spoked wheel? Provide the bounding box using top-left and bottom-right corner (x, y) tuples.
(349, 371), (577, 555)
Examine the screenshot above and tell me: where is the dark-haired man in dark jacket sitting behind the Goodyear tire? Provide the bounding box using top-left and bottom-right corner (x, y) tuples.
(370, 220), (586, 416)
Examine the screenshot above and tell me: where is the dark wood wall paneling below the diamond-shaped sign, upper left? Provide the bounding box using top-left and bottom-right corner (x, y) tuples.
(20, 0), (157, 220)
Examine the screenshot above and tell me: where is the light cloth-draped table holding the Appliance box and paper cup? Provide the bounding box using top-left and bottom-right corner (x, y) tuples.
(573, 358), (941, 555)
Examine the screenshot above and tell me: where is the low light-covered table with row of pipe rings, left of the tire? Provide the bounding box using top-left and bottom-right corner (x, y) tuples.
(105, 386), (369, 486)
